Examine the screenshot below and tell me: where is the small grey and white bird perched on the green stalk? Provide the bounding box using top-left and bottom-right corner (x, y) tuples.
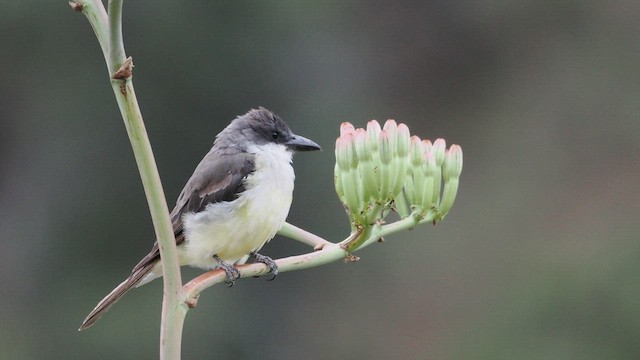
(78, 107), (321, 331)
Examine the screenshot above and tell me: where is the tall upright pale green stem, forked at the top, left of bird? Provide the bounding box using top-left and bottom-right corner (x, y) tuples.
(75, 0), (186, 359)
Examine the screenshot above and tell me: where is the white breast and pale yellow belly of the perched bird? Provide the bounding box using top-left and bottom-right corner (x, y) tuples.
(178, 144), (295, 269)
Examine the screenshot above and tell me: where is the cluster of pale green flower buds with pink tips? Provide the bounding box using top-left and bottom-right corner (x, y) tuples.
(334, 120), (462, 226)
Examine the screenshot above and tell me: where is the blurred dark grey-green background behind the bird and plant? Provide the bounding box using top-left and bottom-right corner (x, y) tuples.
(0, 0), (640, 359)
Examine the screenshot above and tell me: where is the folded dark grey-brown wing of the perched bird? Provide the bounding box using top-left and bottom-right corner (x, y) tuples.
(132, 152), (255, 274)
